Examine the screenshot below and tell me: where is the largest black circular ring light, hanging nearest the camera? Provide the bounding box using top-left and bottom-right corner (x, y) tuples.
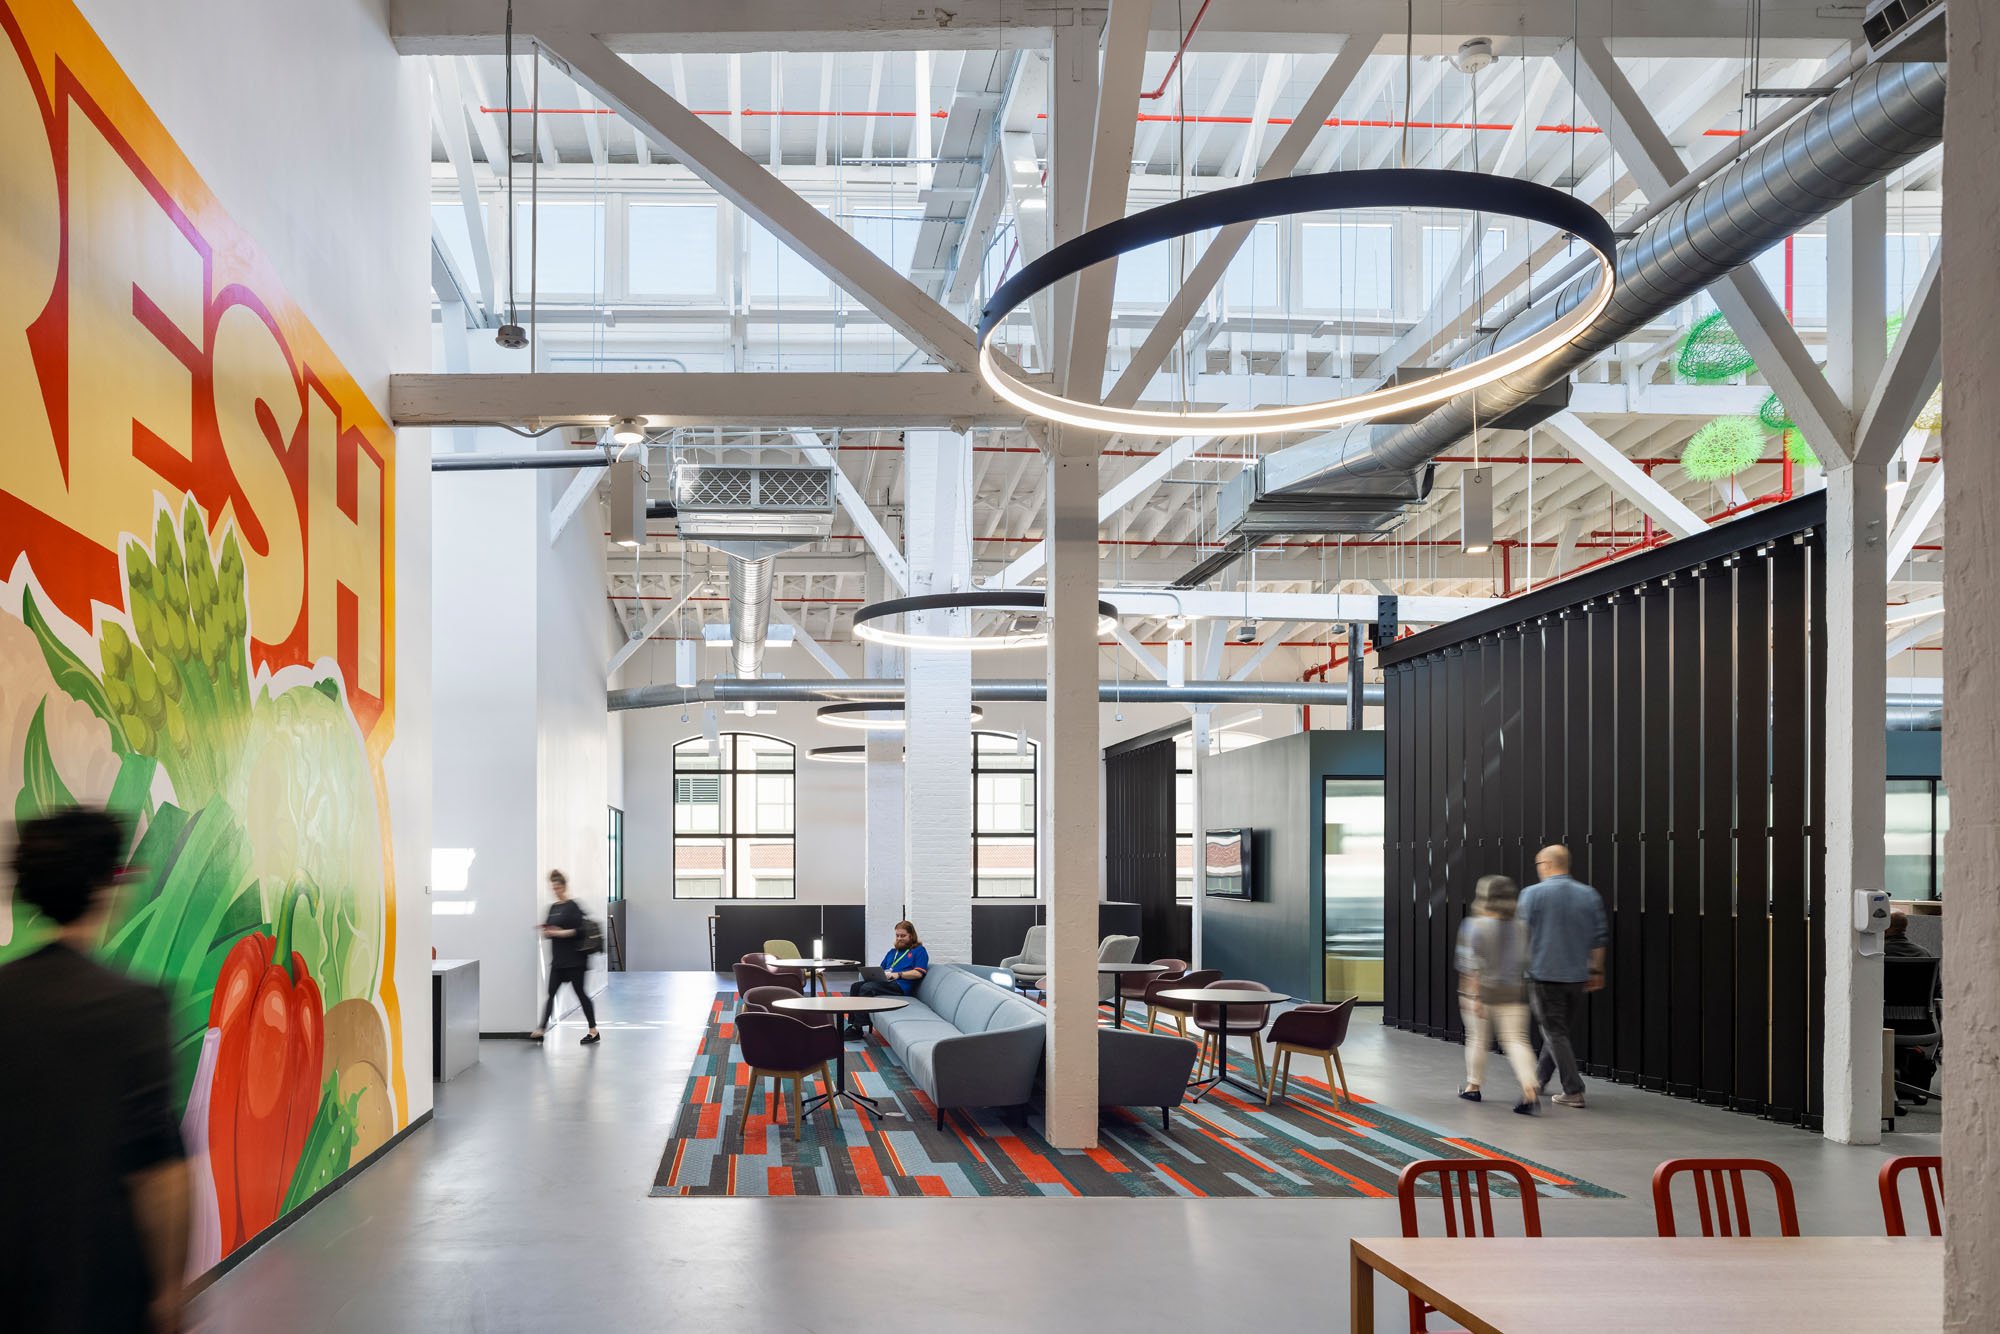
(978, 168), (1618, 436)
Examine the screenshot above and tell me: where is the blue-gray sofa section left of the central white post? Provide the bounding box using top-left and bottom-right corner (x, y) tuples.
(870, 964), (1046, 1126)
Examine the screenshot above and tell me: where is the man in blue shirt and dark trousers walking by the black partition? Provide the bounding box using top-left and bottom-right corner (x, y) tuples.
(1518, 844), (1610, 1108)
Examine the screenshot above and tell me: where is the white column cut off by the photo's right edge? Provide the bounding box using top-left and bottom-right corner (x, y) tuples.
(1942, 13), (2000, 1334)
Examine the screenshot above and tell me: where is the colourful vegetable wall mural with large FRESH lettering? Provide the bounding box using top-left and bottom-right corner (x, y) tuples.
(0, 0), (410, 1272)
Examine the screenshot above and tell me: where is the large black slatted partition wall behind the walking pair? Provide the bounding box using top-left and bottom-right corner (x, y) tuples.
(1384, 496), (1826, 1124)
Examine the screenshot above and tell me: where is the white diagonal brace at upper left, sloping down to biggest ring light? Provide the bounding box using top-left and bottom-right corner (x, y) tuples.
(536, 28), (976, 370)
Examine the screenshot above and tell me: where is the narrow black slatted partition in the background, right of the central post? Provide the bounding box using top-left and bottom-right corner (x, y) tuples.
(1104, 738), (1194, 958)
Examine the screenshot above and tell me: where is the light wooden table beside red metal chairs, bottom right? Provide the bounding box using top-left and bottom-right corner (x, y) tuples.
(1352, 1236), (1944, 1334)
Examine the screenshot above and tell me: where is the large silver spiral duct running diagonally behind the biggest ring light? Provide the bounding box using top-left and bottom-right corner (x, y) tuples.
(1258, 62), (1944, 494)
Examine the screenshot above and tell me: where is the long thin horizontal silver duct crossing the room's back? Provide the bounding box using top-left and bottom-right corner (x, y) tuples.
(608, 680), (1382, 710)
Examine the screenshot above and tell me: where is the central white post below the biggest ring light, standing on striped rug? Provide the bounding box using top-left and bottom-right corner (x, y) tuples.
(1042, 428), (1102, 1148)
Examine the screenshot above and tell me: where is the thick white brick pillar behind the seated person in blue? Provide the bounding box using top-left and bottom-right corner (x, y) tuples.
(902, 430), (972, 964)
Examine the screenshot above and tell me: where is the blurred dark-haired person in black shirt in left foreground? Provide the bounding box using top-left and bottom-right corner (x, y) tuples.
(0, 810), (190, 1334)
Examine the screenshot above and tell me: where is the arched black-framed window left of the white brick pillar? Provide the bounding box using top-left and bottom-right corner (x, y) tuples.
(674, 732), (798, 898)
